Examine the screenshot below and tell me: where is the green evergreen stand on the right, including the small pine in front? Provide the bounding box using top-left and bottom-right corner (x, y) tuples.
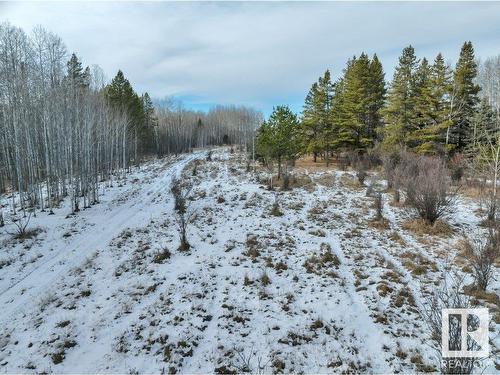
(256, 42), (500, 217)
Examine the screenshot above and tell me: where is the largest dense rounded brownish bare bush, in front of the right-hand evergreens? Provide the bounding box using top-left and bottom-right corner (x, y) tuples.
(398, 156), (456, 224)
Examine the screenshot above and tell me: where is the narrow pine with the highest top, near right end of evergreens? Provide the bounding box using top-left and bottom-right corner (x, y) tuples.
(452, 42), (480, 151)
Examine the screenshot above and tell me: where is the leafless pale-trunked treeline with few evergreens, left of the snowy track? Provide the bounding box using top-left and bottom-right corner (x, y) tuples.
(0, 23), (260, 217)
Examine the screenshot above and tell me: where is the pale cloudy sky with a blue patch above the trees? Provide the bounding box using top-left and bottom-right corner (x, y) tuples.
(0, 2), (500, 113)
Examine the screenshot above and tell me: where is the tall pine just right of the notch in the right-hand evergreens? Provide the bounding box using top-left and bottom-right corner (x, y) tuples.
(384, 46), (419, 147)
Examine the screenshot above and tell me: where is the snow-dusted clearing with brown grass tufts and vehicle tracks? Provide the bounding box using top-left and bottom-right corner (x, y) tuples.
(0, 149), (500, 373)
